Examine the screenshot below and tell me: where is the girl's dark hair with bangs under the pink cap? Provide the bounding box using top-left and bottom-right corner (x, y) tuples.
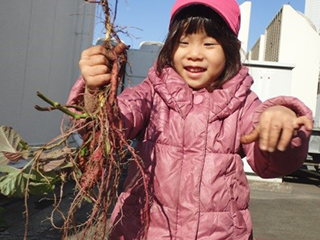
(157, 5), (241, 87)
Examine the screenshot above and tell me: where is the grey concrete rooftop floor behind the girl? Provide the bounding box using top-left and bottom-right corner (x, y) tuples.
(0, 169), (320, 240)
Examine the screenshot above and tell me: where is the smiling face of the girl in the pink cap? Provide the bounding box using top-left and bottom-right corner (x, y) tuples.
(173, 32), (226, 91)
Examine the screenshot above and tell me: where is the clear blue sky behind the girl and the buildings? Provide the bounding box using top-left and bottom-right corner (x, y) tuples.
(94, 0), (305, 48)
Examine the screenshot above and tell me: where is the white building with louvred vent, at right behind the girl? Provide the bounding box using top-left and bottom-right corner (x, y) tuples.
(249, 5), (320, 124)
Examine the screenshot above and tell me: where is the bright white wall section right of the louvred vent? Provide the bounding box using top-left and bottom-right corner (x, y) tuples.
(279, 5), (320, 115)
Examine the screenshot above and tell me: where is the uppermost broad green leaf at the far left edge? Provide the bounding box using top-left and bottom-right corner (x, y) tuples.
(0, 126), (30, 164)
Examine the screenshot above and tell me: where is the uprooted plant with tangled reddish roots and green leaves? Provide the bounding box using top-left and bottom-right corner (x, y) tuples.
(0, 0), (149, 239)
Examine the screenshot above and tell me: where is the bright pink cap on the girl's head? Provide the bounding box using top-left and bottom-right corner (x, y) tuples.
(170, 0), (240, 36)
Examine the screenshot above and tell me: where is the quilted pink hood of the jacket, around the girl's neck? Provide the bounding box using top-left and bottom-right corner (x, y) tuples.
(148, 66), (253, 122)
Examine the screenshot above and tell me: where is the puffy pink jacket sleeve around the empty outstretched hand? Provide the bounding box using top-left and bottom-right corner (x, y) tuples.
(240, 92), (312, 178)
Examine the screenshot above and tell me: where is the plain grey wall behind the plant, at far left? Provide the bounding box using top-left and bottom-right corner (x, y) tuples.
(0, 0), (95, 144)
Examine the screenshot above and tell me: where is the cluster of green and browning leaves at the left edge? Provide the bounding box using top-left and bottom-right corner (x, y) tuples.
(0, 126), (73, 197)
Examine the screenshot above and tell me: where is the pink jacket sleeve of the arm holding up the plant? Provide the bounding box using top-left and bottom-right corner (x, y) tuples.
(67, 76), (154, 139)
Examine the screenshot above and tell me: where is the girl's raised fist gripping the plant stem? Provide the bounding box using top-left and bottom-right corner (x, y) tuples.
(79, 45), (115, 90)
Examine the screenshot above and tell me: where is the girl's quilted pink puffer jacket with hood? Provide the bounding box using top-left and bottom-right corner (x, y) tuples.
(69, 67), (312, 240)
